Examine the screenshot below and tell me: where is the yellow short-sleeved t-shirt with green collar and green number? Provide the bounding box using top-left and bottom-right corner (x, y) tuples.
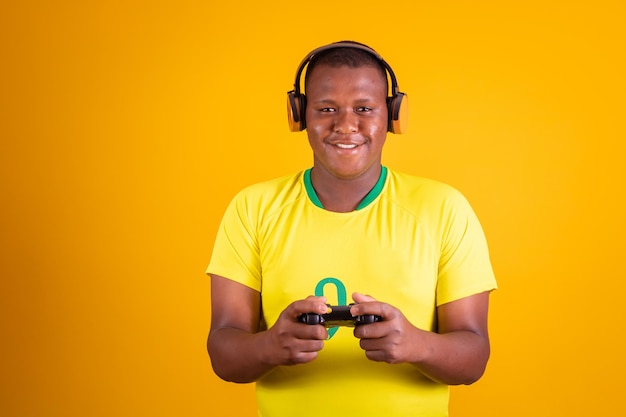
(207, 167), (496, 417)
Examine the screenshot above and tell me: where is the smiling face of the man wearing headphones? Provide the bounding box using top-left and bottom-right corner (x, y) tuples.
(306, 65), (388, 179)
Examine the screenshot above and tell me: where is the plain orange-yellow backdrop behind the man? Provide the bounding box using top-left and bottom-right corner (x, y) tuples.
(0, 0), (626, 417)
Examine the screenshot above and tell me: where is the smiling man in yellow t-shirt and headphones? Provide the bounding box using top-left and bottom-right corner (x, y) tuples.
(207, 42), (496, 417)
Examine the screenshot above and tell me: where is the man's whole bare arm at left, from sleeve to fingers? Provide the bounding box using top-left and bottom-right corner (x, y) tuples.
(207, 275), (328, 383)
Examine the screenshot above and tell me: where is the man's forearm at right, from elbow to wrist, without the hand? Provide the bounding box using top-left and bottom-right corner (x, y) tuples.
(414, 330), (490, 385)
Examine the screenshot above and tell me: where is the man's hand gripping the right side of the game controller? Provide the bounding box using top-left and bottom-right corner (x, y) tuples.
(350, 293), (423, 364)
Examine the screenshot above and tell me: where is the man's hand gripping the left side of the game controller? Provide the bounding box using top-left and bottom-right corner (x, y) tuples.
(265, 296), (328, 366)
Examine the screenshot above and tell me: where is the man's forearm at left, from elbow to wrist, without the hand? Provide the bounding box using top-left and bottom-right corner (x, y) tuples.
(207, 328), (274, 383)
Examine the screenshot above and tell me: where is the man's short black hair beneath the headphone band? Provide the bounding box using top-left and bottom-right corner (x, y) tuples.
(304, 46), (388, 91)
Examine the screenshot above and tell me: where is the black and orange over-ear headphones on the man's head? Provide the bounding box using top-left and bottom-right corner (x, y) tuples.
(287, 41), (409, 134)
